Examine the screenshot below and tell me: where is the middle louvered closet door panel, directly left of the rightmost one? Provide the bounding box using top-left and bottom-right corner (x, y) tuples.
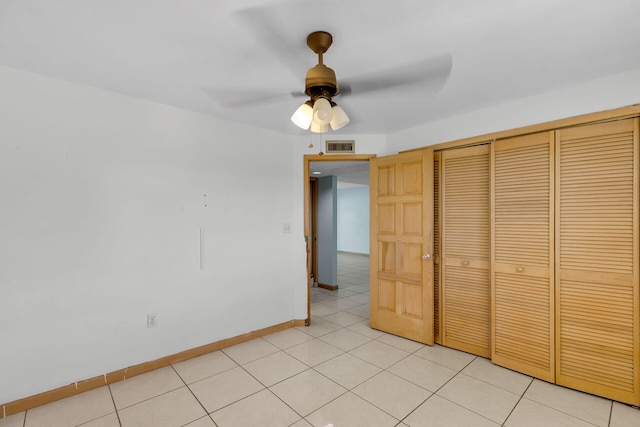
(491, 132), (555, 382)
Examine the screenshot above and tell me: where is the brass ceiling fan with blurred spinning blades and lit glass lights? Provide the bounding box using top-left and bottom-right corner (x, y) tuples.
(216, 1), (452, 133)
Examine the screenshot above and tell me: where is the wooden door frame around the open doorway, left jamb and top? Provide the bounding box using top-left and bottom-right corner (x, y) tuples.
(303, 154), (376, 326)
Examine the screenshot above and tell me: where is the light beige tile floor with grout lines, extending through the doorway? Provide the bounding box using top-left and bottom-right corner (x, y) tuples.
(5, 254), (640, 427)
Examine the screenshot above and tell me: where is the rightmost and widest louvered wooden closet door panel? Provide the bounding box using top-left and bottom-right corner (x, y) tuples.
(555, 118), (640, 405)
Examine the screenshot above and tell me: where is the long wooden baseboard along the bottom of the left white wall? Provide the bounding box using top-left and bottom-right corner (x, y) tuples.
(0, 319), (307, 419)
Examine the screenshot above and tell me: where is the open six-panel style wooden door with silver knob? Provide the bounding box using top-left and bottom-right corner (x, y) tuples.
(369, 149), (434, 345)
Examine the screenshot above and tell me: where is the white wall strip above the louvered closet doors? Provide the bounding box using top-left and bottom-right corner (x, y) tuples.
(387, 68), (640, 153)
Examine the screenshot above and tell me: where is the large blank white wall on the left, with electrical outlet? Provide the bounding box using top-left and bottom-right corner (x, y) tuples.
(0, 68), (306, 404)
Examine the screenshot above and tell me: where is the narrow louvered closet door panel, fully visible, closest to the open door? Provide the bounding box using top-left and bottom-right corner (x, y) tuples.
(439, 145), (490, 357)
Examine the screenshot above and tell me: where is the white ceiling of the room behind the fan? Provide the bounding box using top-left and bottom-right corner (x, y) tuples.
(0, 0), (640, 134)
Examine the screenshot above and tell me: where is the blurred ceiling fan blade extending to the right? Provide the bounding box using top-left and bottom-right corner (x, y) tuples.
(339, 54), (453, 96)
